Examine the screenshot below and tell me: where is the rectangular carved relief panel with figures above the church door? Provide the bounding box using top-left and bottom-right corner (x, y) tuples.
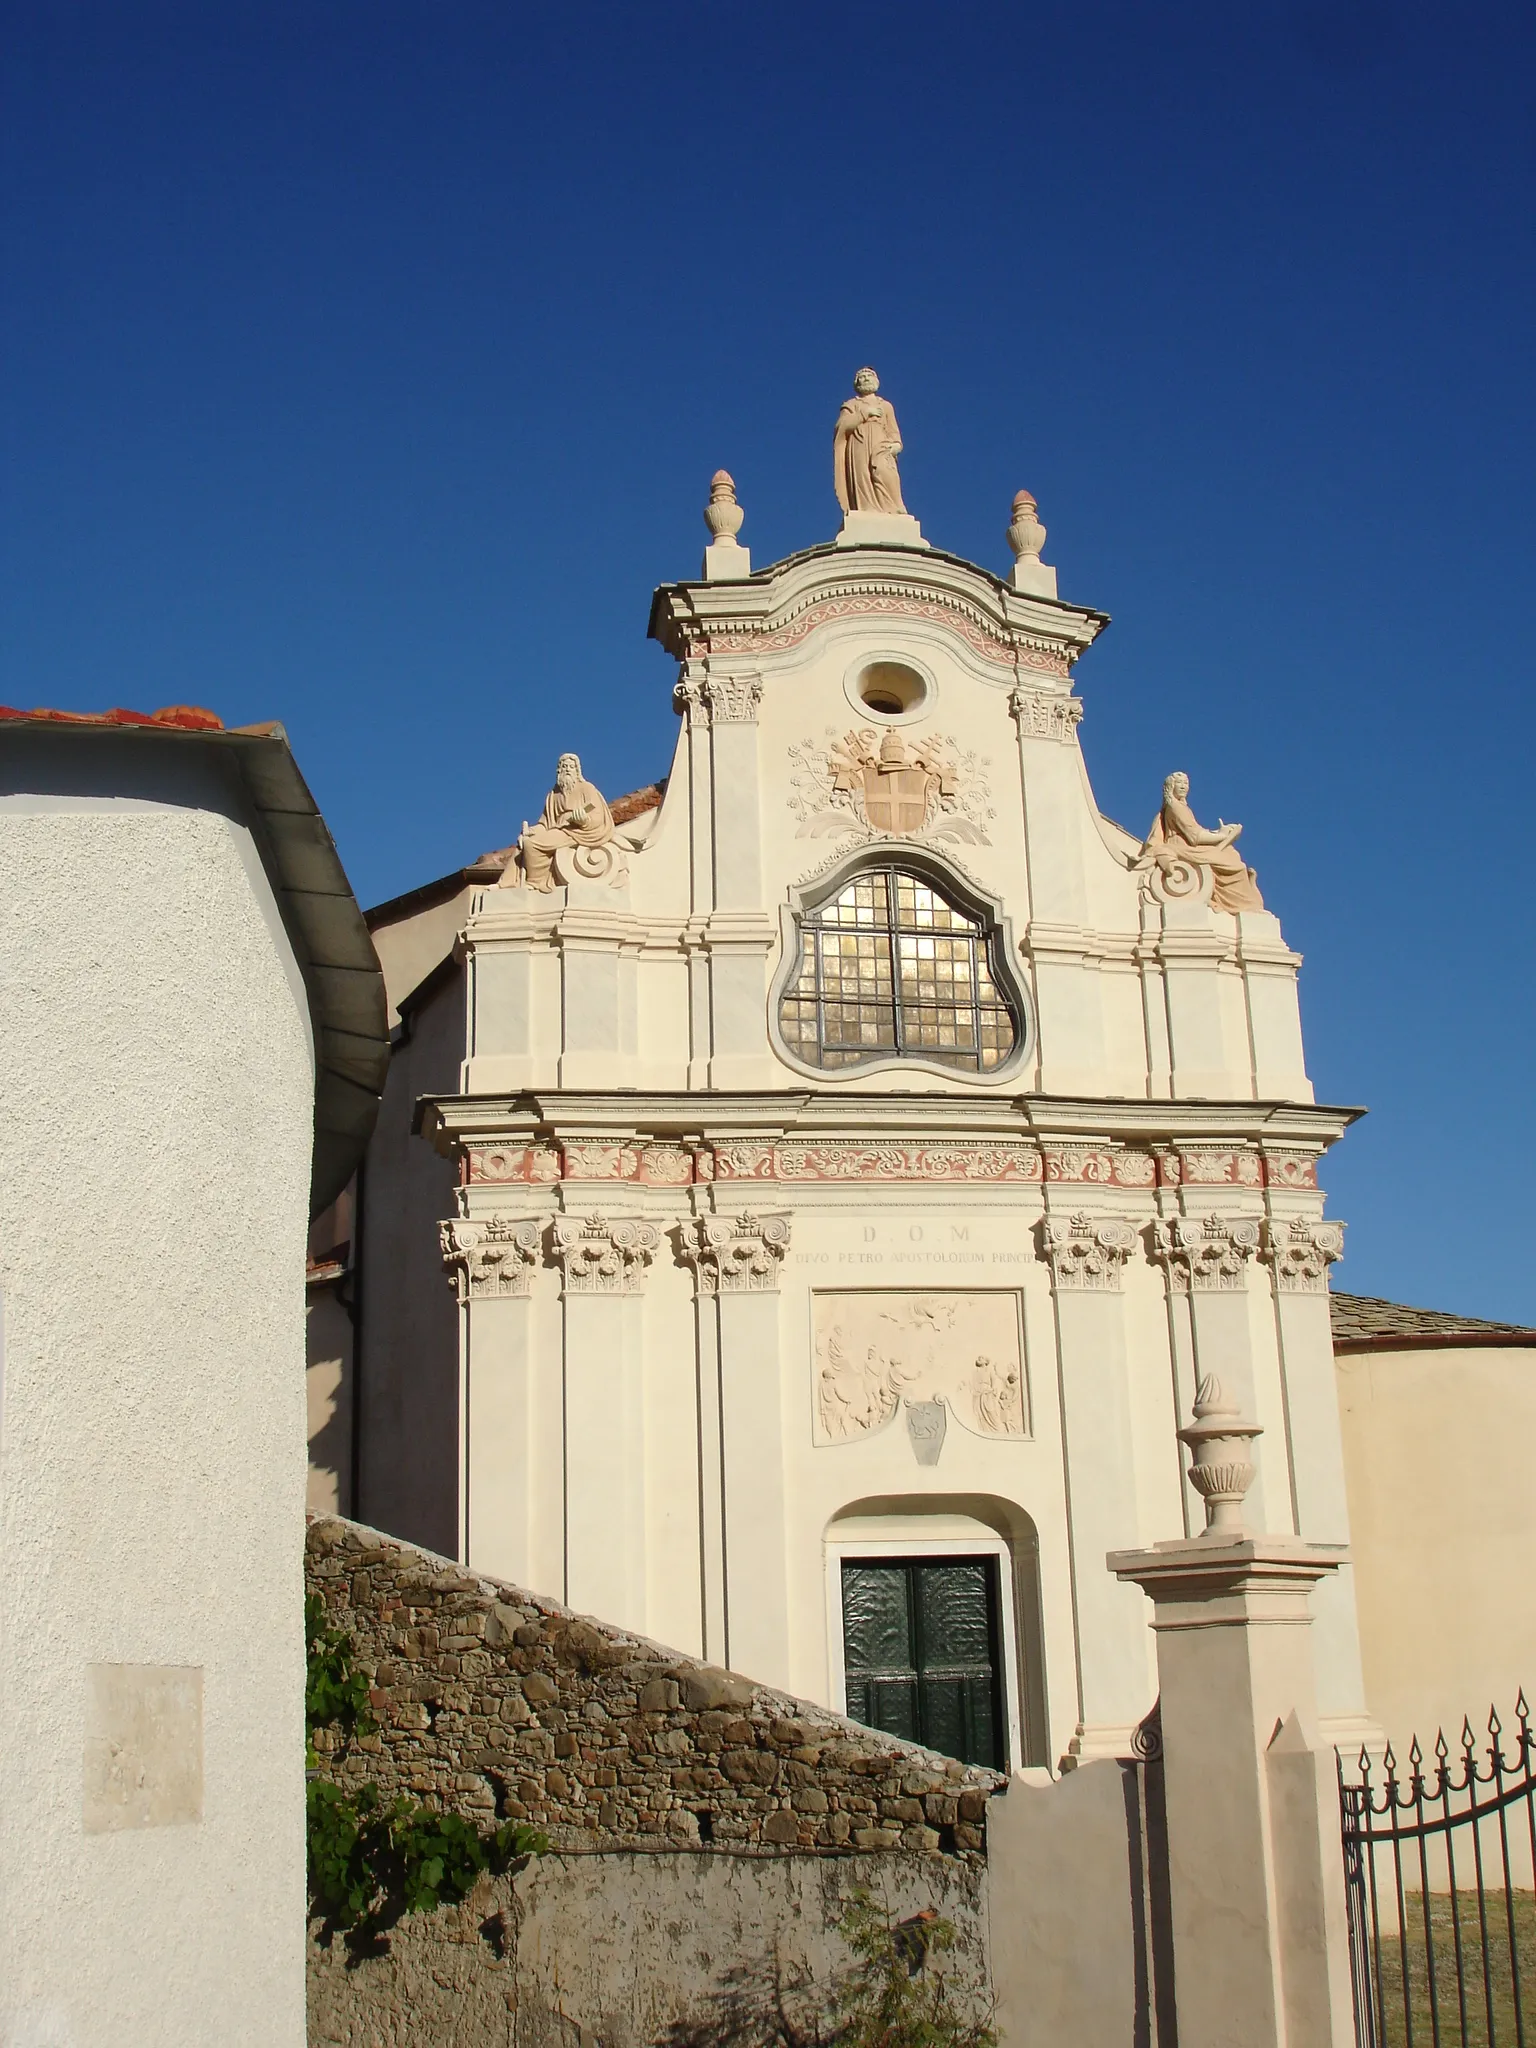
(811, 1290), (1030, 1444)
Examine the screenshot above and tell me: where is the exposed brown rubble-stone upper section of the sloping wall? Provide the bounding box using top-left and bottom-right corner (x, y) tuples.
(305, 1516), (1004, 1858)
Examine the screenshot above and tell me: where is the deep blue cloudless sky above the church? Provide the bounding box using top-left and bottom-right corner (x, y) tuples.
(0, 0), (1536, 1321)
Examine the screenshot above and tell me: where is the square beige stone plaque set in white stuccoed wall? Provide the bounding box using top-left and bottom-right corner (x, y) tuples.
(82, 1665), (203, 1835)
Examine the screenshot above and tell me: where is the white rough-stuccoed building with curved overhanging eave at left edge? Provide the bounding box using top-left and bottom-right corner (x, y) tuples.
(0, 715), (385, 2048)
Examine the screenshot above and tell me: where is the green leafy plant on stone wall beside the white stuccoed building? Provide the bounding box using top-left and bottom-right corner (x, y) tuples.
(303, 1593), (549, 1935)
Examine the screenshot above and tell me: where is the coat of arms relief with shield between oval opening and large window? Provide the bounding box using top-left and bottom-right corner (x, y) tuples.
(788, 725), (997, 846)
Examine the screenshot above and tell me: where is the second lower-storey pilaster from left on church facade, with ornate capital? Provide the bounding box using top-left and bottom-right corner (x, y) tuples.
(553, 1214), (662, 1630)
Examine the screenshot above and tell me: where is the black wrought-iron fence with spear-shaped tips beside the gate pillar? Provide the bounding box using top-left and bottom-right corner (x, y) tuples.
(1339, 1692), (1536, 2048)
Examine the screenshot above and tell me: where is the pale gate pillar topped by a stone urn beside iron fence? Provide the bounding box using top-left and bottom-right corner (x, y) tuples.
(1108, 1378), (1354, 2048)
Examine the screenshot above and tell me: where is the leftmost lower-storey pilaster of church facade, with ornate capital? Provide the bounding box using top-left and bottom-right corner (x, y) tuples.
(438, 1217), (543, 1585)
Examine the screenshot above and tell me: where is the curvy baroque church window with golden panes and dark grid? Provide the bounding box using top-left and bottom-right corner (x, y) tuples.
(778, 866), (1020, 1073)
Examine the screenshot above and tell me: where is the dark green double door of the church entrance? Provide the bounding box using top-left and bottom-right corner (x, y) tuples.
(842, 1556), (1004, 1769)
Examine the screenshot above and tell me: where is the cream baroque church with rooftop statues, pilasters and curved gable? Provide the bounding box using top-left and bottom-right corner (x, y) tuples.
(352, 373), (1366, 1767)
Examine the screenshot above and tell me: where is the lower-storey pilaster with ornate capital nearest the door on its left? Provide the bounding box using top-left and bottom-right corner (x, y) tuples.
(686, 1214), (791, 1688)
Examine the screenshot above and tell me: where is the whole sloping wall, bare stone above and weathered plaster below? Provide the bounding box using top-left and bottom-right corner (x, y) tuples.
(305, 1518), (1004, 2048)
